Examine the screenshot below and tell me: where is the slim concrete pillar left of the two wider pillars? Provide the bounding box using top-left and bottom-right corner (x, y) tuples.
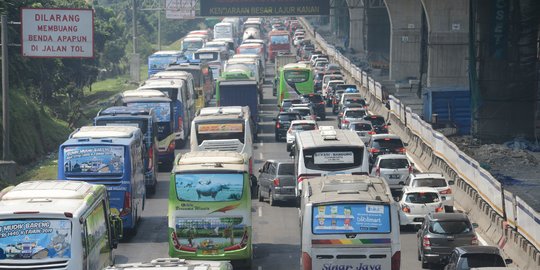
(347, 0), (366, 53)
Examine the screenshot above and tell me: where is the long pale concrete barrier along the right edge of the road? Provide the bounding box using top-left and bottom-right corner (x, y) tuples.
(301, 19), (540, 269)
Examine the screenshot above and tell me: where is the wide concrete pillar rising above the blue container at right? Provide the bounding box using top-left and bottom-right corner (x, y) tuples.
(421, 0), (469, 87)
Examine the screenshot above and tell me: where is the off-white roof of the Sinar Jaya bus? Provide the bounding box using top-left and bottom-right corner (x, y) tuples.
(306, 174), (393, 203)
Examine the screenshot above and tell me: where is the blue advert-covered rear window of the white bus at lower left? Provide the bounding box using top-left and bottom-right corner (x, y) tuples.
(0, 219), (73, 261)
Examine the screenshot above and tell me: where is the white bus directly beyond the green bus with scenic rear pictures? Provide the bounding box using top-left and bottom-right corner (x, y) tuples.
(190, 106), (254, 175)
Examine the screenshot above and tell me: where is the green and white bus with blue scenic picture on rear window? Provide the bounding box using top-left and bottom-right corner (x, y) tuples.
(168, 151), (253, 269)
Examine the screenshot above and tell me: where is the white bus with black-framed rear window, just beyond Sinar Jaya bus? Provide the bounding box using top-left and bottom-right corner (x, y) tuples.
(291, 126), (369, 197)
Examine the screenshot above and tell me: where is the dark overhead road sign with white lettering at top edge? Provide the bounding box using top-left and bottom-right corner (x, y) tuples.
(200, 0), (330, 17)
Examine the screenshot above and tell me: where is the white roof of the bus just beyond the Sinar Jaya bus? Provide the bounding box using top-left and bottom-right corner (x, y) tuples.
(296, 129), (364, 149)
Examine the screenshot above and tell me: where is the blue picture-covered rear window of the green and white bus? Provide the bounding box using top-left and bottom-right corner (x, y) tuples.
(175, 172), (244, 202)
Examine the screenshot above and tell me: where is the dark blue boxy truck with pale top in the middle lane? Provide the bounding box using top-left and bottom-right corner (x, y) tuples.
(216, 68), (259, 137)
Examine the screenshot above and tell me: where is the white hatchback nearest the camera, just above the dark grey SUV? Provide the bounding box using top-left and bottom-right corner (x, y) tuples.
(398, 188), (444, 226)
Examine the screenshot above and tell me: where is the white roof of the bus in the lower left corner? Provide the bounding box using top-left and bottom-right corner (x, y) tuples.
(0, 180), (106, 215)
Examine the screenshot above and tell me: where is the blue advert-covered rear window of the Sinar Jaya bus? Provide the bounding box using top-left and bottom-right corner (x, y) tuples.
(311, 203), (391, 234)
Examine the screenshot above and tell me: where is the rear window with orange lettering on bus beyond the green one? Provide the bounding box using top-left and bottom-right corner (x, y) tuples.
(196, 122), (245, 144)
